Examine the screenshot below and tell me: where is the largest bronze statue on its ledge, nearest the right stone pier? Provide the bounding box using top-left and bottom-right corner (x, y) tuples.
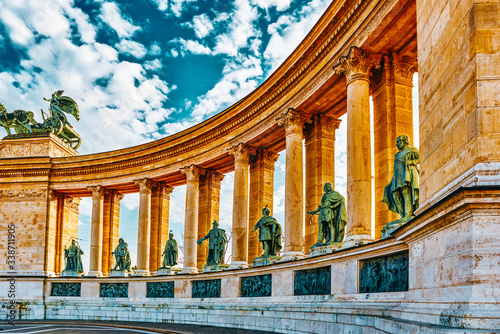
(382, 135), (419, 237)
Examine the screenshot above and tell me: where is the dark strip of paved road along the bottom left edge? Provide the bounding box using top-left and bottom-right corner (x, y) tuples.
(0, 321), (273, 334)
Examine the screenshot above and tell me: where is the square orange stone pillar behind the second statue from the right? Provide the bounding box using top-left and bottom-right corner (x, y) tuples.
(304, 115), (340, 254)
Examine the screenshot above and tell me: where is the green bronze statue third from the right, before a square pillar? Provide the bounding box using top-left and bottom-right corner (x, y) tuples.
(252, 205), (281, 258)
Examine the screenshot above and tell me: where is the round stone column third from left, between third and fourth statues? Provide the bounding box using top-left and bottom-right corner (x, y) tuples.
(181, 165), (204, 274)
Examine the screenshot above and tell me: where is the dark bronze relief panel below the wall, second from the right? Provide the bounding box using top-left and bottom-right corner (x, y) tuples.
(293, 266), (332, 296)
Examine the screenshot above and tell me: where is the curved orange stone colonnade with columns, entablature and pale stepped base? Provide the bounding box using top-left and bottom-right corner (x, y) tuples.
(0, 0), (498, 333)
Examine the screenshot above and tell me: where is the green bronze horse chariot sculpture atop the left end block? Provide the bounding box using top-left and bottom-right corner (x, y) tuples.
(0, 90), (81, 150)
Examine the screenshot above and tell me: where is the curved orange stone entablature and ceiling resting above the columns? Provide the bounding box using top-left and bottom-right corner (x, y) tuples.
(0, 0), (417, 197)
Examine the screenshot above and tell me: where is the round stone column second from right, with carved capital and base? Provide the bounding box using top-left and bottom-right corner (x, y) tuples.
(277, 108), (304, 261)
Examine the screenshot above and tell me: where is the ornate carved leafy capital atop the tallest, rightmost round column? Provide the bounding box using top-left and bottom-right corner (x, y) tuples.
(333, 46), (382, 85)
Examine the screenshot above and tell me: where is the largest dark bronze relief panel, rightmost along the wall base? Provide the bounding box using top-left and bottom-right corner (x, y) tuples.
(359, 252), (408, 293)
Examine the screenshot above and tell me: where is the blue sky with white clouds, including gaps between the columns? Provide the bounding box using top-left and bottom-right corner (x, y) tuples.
(0, 0), (416, 270)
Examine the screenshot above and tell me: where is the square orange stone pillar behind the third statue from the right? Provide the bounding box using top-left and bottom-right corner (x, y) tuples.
(248, 149), (279, 264)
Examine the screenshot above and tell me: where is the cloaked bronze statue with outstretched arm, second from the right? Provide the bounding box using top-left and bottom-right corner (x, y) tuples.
(307, 183), (346, 247)
